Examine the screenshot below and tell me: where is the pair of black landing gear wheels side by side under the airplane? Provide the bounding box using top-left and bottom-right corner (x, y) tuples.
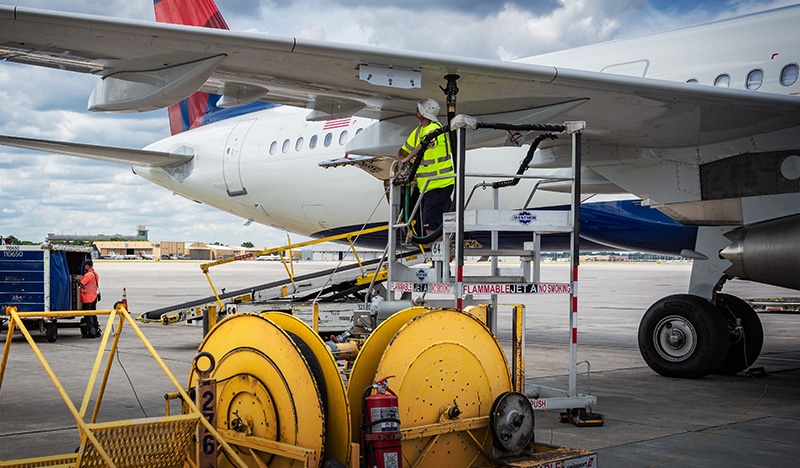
(639, 293), (764, 379)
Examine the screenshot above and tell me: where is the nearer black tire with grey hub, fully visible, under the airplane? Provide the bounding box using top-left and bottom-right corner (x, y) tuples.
(639, 294), (730, 379)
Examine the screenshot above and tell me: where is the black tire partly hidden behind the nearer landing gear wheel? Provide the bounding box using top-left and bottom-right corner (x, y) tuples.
(714, 294), (764, 375)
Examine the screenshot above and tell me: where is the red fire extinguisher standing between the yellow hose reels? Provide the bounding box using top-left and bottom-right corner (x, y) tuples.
(361, 375), (403, 468)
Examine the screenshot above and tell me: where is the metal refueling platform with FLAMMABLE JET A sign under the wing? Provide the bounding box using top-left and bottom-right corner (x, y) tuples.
(386, 115), (603, 426)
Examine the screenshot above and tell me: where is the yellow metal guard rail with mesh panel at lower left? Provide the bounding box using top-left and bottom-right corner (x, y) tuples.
(0, 302), (247, 468)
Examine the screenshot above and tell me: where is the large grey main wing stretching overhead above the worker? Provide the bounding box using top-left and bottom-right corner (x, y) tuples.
(0, 6), (800, 148)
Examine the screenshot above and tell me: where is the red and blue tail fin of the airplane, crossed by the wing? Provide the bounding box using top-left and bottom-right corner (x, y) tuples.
(153, 0), (228, 135)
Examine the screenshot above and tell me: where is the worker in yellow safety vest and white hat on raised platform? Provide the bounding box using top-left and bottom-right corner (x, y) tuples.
(397, 98), (455, 235)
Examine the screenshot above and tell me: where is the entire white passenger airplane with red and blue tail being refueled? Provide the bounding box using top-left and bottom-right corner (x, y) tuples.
(0, 0), (800, 378)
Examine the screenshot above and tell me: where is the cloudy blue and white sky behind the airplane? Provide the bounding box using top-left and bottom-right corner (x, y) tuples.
(0, 0), (797, 246)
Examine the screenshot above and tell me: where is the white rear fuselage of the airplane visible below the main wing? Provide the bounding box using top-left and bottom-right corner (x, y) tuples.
(141, 106), (633, 243)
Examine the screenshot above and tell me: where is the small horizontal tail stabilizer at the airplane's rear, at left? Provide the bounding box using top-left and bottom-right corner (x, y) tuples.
(0, 136), (193, 167)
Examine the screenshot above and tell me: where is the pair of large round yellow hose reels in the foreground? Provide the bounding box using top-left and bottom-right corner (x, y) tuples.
(189, 307), (512, 467)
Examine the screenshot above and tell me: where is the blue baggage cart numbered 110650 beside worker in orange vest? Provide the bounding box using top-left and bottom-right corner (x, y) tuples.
(0, 243), (92, 343)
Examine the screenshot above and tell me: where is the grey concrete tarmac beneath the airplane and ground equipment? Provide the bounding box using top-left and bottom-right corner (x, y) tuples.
(0, 261), (800, 468)
